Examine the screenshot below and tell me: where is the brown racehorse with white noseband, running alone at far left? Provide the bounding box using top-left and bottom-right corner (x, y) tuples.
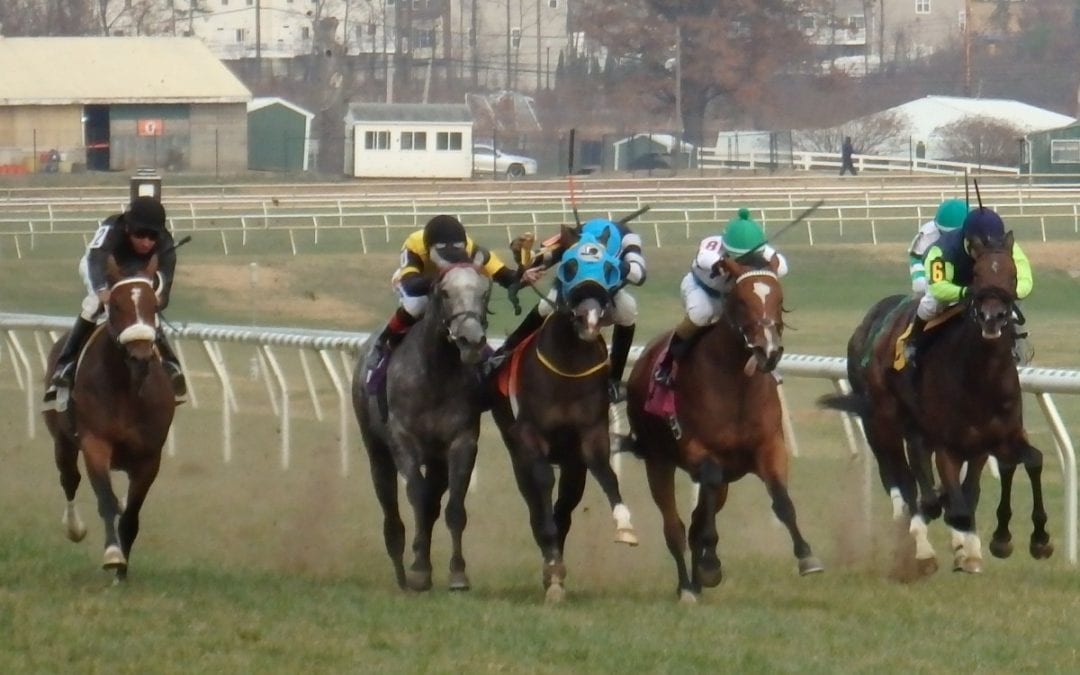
(43, 256), (176, 581)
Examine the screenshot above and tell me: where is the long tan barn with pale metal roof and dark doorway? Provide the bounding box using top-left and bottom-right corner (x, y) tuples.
(0, 37), (252, 173)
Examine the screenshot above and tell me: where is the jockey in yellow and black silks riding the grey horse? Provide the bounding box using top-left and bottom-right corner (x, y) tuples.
(370, 215), (517, 373)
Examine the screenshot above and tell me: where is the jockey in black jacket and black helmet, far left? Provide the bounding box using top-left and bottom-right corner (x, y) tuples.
(45, 197), (187, 402)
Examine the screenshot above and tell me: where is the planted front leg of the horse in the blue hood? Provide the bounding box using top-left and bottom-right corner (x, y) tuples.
(511, 429), (566, 603)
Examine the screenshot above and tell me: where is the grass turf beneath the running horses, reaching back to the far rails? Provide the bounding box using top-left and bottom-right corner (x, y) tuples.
(0, 198), (1080, 673)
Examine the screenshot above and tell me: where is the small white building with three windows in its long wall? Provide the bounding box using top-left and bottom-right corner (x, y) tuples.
(345, 103), (473, 178)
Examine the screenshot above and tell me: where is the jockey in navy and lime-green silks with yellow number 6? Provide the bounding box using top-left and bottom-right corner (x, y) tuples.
(904, 206), (1032, 377)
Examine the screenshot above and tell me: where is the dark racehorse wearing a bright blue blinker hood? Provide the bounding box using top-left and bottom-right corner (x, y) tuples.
(491, 228), (637, 603)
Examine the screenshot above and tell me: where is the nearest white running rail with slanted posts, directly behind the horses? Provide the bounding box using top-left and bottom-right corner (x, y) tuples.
(0, 313), (1080, 564)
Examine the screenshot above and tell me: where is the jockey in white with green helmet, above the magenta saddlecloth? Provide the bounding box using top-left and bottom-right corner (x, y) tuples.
(652, 208), (787, 387)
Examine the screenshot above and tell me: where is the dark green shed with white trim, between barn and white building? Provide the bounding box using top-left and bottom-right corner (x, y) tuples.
(247, 96), (315, 172)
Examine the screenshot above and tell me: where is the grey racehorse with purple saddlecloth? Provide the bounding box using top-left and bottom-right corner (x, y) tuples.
(352, 260), (491, 591)
